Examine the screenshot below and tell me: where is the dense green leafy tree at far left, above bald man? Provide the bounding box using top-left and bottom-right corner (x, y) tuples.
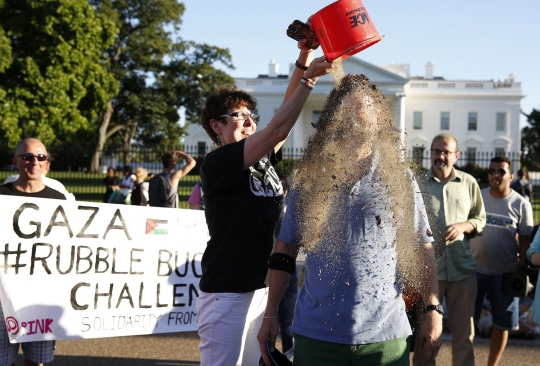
(0, 0), (117, 148)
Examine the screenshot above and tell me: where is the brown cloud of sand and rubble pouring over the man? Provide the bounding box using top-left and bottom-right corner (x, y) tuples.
(292, 61), (428, 288)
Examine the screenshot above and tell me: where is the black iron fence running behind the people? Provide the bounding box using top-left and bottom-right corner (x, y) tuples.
(0, 144), (540, 220)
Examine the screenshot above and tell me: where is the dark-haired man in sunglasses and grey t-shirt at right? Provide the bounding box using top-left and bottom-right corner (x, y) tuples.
(471, 156), (534, 365)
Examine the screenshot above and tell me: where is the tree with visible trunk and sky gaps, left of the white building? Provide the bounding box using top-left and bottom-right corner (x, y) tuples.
(90, 0), (234, 171)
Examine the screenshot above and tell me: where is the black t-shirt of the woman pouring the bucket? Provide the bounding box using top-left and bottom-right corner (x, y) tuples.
(200, 140), (283, 293)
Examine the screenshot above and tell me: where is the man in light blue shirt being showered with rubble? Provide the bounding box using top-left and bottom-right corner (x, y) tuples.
(258, 75), (442, 366)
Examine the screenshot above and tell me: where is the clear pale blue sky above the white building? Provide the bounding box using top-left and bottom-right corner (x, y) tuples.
(179, 0), (540, 126)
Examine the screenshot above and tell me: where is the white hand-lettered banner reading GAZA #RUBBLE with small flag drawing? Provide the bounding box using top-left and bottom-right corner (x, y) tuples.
(0, 196), (208, 342)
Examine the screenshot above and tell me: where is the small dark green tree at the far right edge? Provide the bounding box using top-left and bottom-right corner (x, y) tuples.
(521, 108), (540, 171)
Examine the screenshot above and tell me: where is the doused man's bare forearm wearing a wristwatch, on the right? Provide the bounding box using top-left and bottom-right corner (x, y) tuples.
(417, 243), (442, 365)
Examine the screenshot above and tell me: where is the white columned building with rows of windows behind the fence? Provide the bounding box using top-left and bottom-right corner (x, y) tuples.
(185, 57), (524, 167)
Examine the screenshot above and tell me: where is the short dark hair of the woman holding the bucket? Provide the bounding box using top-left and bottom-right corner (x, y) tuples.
(201, 86), (257, 144)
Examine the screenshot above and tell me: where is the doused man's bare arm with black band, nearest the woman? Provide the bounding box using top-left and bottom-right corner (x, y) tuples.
(257, 240), (298, 366)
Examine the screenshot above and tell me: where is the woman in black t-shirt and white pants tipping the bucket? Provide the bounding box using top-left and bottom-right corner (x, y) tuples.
(197, 29), (332, 366)
